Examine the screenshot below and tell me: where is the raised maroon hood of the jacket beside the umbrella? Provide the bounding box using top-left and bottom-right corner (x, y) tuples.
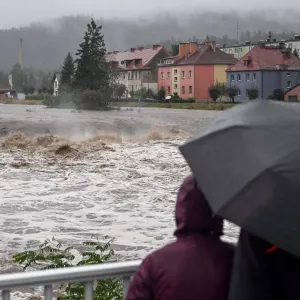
(174, 175), (223, 237)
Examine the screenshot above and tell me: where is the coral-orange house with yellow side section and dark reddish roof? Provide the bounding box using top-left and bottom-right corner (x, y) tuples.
(158, 42), (237, 100)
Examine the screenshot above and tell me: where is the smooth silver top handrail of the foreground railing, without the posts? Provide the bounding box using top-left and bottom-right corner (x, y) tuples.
(0, 260), (141, 290)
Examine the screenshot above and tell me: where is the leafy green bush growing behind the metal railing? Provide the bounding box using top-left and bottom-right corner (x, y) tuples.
(13, 237), (123, 300)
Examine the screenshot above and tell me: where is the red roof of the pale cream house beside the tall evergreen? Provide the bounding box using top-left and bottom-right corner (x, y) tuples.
(107, 46), (169, 70)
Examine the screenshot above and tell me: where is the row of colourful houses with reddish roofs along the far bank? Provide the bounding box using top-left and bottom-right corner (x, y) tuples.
(53, 35), (300, 101)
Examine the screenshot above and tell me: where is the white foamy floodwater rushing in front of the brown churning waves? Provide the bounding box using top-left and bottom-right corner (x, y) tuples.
(0, 141), (237, 258)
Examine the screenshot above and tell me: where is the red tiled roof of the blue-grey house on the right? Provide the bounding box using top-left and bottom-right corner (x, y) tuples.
(229, 46), (300, 71)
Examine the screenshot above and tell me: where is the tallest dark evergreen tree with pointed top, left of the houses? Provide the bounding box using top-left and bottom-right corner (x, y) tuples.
(74, 19), (109, 91)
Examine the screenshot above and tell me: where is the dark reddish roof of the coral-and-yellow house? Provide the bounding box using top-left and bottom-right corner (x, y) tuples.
(177, 45), (238, 65)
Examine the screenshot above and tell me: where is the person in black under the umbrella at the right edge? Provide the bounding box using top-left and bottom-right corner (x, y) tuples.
(228, 230), (300, 300)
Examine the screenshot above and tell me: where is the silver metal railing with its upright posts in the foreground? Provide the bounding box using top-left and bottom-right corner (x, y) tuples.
(0, 261), (141, 300)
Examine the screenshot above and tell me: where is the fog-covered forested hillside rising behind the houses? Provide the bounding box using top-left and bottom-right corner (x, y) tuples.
(0, 10), (300, 69)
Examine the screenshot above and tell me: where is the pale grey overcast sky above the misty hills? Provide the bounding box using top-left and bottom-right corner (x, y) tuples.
(0, 0), (300, 28)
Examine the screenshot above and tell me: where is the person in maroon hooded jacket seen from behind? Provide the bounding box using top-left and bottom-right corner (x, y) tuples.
(126, 176), (234, 300)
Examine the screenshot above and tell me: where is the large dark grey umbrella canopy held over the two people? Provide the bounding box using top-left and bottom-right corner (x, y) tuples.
(180, 100), (300, 257)
